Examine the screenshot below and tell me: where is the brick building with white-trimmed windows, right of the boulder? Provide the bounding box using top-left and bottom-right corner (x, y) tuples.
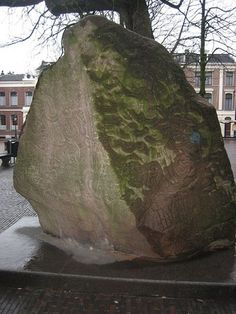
(176, 52), (236, 137)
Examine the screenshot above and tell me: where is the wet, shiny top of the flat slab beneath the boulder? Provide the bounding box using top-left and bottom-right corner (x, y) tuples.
(0, 217), (236, 283)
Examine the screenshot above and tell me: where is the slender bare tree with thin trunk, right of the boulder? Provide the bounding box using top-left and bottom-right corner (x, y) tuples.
(171, 0), (236, 97)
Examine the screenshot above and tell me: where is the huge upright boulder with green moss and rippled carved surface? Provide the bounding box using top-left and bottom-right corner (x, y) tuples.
(14, 16), (235, 259)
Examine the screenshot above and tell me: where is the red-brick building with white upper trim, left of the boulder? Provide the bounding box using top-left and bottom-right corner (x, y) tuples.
(0, 73), (36, 151)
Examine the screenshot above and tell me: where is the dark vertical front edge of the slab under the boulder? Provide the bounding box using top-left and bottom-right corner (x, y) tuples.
(0, 270), (236, 299)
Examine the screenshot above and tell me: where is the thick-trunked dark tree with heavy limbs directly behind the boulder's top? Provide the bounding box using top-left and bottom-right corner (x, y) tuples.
(0, 0), (184, 38)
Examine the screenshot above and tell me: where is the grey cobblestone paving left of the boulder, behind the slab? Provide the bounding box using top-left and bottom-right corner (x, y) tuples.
(0, 166), (36, 232)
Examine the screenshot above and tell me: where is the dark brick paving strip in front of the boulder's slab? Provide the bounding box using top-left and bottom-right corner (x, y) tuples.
(0, 287), (236, 314)
